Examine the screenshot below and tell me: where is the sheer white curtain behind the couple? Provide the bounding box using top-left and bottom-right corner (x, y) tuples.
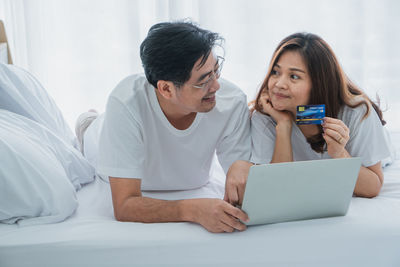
(0, 0), (400, 130)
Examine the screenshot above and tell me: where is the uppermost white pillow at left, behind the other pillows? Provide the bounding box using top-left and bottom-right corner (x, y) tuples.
(0, 63), (78, 147)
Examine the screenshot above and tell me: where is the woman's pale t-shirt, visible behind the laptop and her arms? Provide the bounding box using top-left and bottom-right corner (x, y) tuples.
(250, 105), (390, 167)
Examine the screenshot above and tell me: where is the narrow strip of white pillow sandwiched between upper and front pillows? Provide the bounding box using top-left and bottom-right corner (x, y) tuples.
(0, 109), (95, 190)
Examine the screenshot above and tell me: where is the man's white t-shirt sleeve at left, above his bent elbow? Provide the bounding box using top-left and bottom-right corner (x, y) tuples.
(98, 97), (145, 179)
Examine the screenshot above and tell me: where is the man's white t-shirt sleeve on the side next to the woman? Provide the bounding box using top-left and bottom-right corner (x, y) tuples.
(216, 97), (251, 173)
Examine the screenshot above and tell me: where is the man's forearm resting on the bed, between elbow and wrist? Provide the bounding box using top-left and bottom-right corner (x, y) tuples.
(114, 197), (194, 223)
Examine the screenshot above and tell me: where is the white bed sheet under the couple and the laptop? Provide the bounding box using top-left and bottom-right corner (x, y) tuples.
(0, 133), (400, 267)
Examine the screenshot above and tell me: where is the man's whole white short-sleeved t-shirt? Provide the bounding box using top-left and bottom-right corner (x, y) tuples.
(97, 74), (251, 190)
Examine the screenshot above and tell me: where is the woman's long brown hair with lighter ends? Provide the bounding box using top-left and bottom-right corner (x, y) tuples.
(254, 33), (386, 153)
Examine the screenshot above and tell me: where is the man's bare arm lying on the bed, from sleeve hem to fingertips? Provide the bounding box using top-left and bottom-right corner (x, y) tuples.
(110, 177), (249, 233)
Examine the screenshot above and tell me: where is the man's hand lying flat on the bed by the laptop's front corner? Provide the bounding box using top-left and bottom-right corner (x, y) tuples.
(188, 198), (249, 233)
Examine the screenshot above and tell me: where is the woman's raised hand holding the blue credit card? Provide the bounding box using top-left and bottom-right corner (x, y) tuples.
(322, 117), (350, 158)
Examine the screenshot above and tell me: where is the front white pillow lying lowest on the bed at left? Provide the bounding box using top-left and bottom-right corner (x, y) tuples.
(0, 110), (78, 225)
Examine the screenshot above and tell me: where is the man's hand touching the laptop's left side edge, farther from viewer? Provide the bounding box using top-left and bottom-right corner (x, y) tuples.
(224, 160), (253, 206)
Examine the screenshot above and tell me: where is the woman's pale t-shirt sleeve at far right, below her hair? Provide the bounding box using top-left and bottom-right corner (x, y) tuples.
(346, 107), (390, 167)
